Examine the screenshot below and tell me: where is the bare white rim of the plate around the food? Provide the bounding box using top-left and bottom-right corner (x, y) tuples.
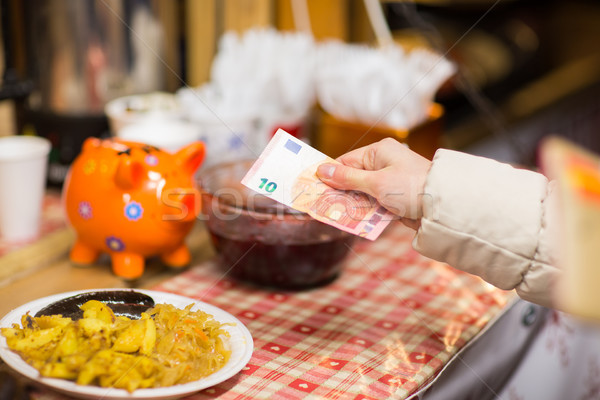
(0, 289), (254, 399)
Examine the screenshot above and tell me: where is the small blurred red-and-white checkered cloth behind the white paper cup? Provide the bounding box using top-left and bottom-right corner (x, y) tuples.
(0, 191), (67, 257)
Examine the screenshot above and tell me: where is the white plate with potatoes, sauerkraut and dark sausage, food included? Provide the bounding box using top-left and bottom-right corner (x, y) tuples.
(0, 289), (254, 400)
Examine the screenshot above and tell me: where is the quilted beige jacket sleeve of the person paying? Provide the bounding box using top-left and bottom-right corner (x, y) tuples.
(413, 150), (560, 307)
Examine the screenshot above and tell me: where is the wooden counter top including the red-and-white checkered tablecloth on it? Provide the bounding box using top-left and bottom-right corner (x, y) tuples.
(0, 192), (514, 400)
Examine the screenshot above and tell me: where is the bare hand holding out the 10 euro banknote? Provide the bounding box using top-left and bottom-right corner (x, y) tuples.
(317, 138), (431, 229)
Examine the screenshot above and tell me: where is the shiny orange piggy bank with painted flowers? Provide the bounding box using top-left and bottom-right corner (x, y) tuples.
(63, 138), (205, 279)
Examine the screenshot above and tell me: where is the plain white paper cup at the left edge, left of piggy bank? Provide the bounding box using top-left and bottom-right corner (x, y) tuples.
(0, 136), (51, 242)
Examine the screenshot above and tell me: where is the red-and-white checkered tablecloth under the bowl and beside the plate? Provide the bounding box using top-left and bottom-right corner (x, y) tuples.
(154, 224), (514, 400)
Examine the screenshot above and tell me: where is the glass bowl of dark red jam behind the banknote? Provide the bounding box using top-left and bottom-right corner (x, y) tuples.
(198, 160), (355, 289)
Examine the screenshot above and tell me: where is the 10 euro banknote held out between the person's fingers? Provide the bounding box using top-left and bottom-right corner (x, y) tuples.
(242, 129), (394, 240)
